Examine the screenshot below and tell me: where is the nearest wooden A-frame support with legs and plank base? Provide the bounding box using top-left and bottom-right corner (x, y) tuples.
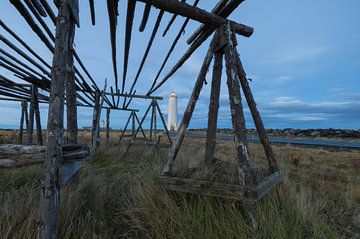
(161, 21), (283, 228)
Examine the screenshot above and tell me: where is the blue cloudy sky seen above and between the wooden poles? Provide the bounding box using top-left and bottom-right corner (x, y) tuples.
(0, 0), (360, 129)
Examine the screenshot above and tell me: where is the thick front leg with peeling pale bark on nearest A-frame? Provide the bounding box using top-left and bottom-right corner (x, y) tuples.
(223, 24), (255, 185)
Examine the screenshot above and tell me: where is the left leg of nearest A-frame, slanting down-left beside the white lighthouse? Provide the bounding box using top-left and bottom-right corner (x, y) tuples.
(161, 34), (218, 176)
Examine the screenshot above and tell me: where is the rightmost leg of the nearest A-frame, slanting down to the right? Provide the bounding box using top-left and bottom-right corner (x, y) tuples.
(234, 47), (279, 172)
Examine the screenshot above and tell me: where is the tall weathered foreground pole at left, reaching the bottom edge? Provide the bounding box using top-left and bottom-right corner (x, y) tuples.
(39, 0), (75, 239)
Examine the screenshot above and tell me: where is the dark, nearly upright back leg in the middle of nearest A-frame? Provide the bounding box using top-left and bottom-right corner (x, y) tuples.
(205, 51), (223, 166)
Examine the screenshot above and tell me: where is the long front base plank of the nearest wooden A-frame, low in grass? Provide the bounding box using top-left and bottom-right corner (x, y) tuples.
(159, 176), (257, 204)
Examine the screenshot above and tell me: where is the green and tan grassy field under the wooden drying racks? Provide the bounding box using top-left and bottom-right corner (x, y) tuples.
(0, 132), (360, 238)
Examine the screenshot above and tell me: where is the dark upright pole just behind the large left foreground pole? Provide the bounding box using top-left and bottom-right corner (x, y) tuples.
(66, 29), (78, 144)
